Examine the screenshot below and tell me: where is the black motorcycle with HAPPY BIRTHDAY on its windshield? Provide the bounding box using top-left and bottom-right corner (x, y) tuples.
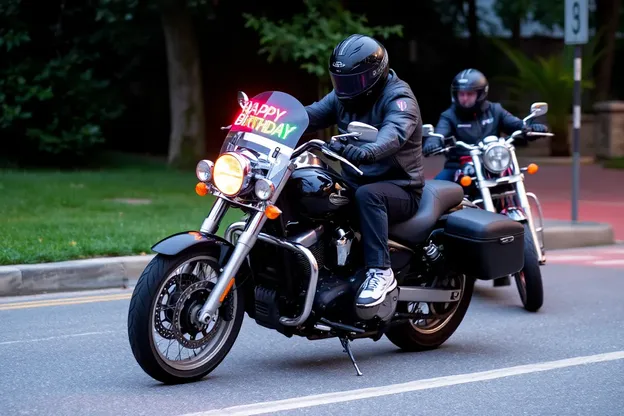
(128, 91), (524, 384)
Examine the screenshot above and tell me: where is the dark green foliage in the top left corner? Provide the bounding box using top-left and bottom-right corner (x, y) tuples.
(0, 0), (154, 166)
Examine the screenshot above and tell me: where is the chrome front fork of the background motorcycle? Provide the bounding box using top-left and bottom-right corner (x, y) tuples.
(472, 149), (546, 264)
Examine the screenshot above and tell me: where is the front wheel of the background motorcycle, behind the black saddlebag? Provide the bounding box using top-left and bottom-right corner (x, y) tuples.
(514, 224), (544, 312)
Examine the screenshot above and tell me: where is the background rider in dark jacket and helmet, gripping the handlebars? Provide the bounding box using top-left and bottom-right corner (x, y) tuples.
(423, 69), (548, 181)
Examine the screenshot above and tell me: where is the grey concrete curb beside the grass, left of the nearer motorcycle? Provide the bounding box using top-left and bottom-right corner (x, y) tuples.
(0, 255), (154, 296)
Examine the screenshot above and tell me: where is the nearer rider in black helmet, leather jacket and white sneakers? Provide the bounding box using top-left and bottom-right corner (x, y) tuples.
(306, 34), (425, 307)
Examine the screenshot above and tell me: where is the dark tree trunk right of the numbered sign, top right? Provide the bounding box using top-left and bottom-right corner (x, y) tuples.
(595, 0), (622, 101)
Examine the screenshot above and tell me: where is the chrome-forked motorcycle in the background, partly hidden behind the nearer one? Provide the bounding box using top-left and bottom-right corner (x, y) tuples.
(423, 102), (553, 312)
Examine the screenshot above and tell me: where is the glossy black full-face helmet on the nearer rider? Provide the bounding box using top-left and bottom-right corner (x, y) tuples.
(329, 35), (389, 103)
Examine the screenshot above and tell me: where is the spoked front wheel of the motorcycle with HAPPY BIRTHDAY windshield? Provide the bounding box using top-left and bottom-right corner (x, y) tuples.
(128, 249), (244, 384)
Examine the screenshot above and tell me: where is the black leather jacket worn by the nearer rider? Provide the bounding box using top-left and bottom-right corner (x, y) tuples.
(306, 70), (425, 189)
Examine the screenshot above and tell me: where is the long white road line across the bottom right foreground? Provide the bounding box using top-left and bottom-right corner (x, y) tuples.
(182, 351), (624, 416)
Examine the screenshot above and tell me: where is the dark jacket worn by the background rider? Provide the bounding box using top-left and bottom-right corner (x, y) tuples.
(424, 101), (523, 166)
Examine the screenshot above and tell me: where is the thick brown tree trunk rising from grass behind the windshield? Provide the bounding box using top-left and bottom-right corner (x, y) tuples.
(160, 0), (206, 167)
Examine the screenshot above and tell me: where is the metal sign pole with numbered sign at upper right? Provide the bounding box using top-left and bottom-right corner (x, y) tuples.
(565, 0), (589, 222)
